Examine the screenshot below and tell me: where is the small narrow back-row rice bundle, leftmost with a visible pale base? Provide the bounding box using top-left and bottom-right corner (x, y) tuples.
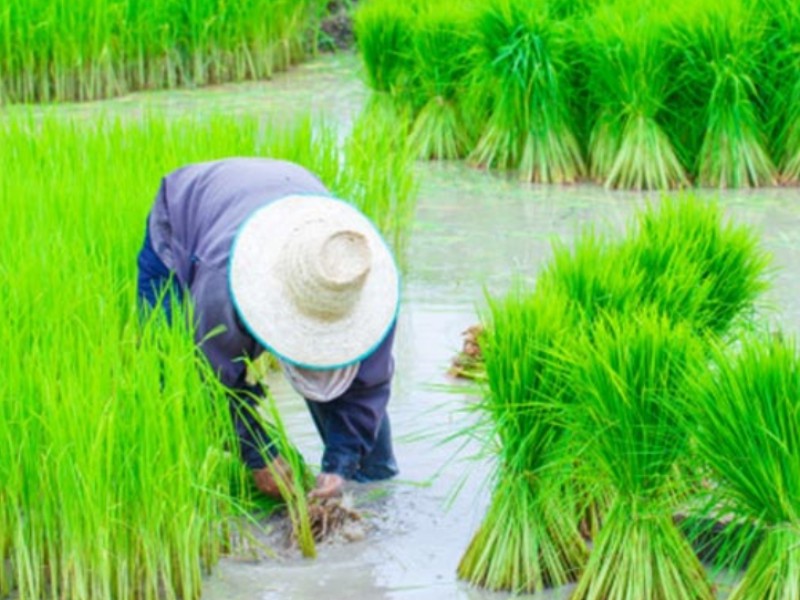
(411, 1), (472, 159)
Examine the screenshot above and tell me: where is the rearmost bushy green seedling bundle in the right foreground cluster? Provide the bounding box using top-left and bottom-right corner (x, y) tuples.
(620, 195), (770, 336)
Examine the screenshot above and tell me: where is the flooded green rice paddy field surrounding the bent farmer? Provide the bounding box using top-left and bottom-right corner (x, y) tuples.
(0, 0), (800, 600)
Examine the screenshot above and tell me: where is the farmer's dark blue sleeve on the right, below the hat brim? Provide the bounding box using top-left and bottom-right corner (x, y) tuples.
(312, 326), (394, 479)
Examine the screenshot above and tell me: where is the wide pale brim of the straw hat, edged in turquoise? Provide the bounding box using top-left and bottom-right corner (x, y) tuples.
(229, 196), (399, 369)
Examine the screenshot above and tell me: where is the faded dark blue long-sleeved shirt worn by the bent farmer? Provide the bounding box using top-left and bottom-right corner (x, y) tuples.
(148, 158), (394, 478)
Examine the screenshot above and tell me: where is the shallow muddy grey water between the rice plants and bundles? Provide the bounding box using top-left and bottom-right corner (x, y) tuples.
(25, 55), (800, 600)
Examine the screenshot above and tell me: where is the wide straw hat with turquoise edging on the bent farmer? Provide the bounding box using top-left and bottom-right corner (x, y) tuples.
(229, 196), (399, 369)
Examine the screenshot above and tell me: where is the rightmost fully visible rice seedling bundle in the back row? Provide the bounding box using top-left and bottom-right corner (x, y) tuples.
(674, 0), (776, 188)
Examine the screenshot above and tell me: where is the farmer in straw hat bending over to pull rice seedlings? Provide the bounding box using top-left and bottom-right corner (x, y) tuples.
(138, 158), (399, 498)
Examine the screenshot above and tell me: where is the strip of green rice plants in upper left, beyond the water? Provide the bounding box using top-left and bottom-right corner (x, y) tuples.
(0, 0), (325, 102)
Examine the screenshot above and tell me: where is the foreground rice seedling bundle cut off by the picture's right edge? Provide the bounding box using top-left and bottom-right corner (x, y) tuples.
(680, 336), (800, 600)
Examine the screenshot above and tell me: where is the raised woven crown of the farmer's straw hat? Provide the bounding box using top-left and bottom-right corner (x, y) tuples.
(282, 224), (372, 319)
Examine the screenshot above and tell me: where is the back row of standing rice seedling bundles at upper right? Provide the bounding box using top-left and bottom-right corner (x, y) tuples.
(357, 0), (800, 189)
